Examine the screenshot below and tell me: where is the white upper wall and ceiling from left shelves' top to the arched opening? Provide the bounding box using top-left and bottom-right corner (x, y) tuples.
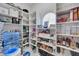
(12, 3), (56, 24)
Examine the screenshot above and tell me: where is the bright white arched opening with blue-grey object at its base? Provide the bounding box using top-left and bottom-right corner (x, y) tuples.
(42, 13), (56, 27)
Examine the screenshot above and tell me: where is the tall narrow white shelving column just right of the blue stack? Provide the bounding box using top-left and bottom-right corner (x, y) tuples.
(22, 12), (29, 53)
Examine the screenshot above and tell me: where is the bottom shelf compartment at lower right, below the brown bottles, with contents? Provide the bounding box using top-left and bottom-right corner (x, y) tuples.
(56, 45), (79, 56)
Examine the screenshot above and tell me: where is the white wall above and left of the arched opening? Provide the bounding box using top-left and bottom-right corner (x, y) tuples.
(31, 3), (56, 24)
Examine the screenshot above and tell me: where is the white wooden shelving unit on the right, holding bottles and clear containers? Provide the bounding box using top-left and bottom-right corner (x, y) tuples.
(56, 5), (79, 55)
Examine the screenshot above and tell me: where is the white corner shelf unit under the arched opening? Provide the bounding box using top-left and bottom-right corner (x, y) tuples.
(36, 24), (56, 56)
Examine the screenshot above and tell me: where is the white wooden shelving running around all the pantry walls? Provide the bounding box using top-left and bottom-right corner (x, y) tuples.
(0, 3), (79, 56)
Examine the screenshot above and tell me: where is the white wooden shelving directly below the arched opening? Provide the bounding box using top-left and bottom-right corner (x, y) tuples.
(37, 24), (56, 56)
